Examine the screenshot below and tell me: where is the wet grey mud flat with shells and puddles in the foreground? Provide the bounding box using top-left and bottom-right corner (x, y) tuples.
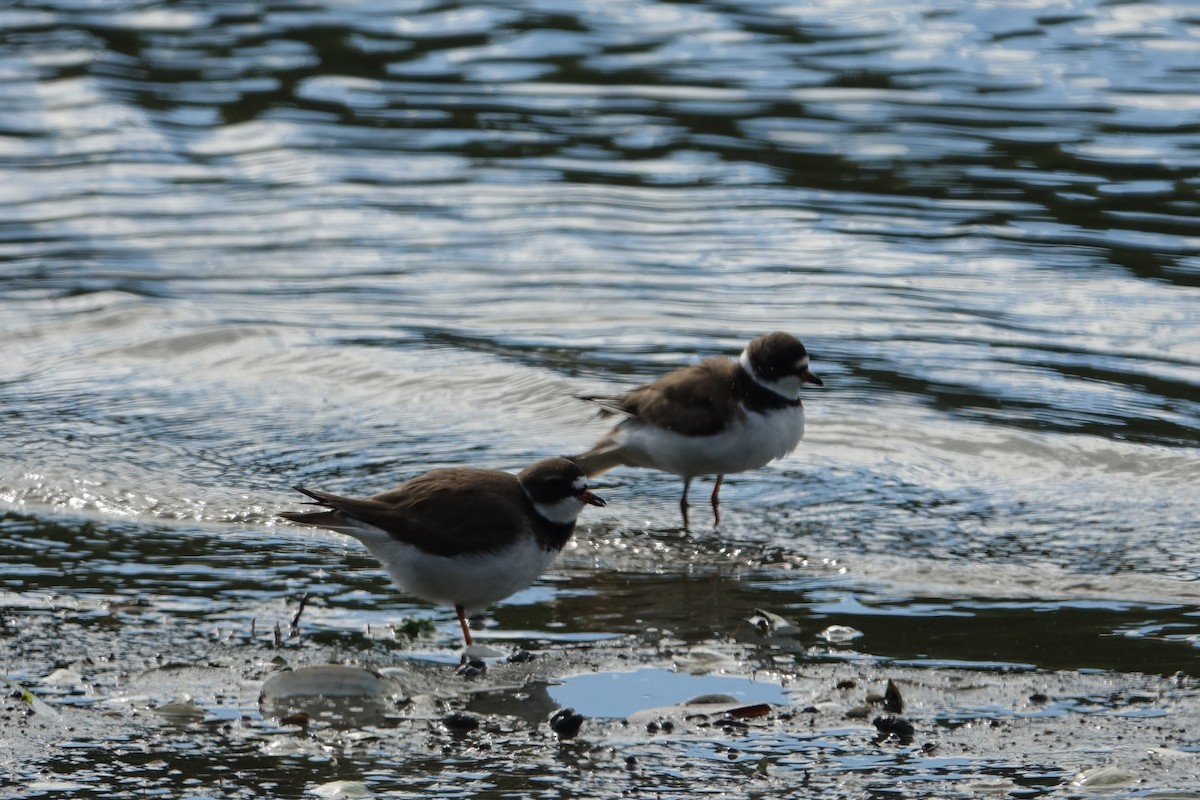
(0, 606), (1200, 798)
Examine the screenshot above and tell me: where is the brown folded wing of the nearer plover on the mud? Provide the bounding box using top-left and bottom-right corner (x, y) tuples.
(283, 468), (528, 555)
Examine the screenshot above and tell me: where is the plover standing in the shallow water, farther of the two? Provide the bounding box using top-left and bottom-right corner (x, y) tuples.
(571, 332), (824, 528)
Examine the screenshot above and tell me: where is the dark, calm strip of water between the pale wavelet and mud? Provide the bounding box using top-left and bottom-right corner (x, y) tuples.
(0, 515), (1200, 681)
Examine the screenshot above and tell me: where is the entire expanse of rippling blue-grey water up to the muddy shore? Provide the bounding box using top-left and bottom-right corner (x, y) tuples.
(0, 0), (1200, 796)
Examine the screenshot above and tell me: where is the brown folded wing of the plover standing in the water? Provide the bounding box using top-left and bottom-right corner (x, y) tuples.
(614, 359), (742, 437)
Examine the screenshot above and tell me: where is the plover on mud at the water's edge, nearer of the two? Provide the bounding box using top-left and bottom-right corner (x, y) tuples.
(280, 458), (605, 646)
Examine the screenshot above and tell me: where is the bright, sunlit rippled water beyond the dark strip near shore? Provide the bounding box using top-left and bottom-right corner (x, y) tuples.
(0, 2), (1198, 577)
